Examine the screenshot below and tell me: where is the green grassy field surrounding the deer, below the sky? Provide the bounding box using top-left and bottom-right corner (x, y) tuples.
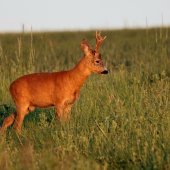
(0, 28), (170, 170)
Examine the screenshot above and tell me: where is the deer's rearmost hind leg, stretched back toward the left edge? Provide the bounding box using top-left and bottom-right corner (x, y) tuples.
(1, 111), (17, 133)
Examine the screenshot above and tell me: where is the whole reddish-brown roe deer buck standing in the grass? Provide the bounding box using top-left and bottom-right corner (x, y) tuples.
(1, 31), (108, 133)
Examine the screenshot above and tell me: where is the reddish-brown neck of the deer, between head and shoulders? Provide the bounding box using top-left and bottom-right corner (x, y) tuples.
(70, 56), (91, 88)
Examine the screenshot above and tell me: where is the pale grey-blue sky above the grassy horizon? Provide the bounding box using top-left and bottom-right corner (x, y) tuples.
(0, 0), (170, 33)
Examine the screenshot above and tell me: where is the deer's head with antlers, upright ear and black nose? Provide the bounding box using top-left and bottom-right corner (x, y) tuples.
(81, 31), (108, 74)
